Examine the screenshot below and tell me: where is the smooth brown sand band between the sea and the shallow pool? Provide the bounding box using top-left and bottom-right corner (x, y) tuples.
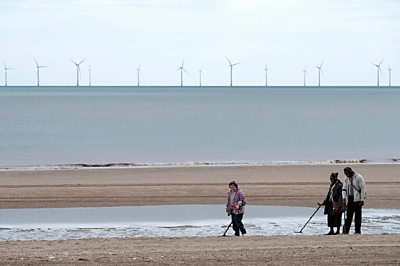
(0, 164), (400, 208)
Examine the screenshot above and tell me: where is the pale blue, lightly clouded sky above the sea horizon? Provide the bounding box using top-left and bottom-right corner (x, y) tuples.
(0, 0), (400, 86)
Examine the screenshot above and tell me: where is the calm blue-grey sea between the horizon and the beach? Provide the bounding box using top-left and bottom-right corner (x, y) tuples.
(0, 87), (400, 167)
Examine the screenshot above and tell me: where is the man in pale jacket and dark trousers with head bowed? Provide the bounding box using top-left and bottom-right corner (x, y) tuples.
(342, 167), (365, 234)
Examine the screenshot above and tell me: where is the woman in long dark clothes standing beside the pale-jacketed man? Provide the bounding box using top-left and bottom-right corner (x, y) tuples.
(321, 173), (344, 235)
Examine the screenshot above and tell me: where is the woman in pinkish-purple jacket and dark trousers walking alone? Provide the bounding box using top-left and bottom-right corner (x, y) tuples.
(226, 181), (246, 236)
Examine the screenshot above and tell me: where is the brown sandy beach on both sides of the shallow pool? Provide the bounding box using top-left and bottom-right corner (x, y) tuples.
(0, 164), (400, 265)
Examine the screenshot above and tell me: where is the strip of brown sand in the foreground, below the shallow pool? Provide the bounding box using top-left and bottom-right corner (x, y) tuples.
(0, 235), (400, 265)
